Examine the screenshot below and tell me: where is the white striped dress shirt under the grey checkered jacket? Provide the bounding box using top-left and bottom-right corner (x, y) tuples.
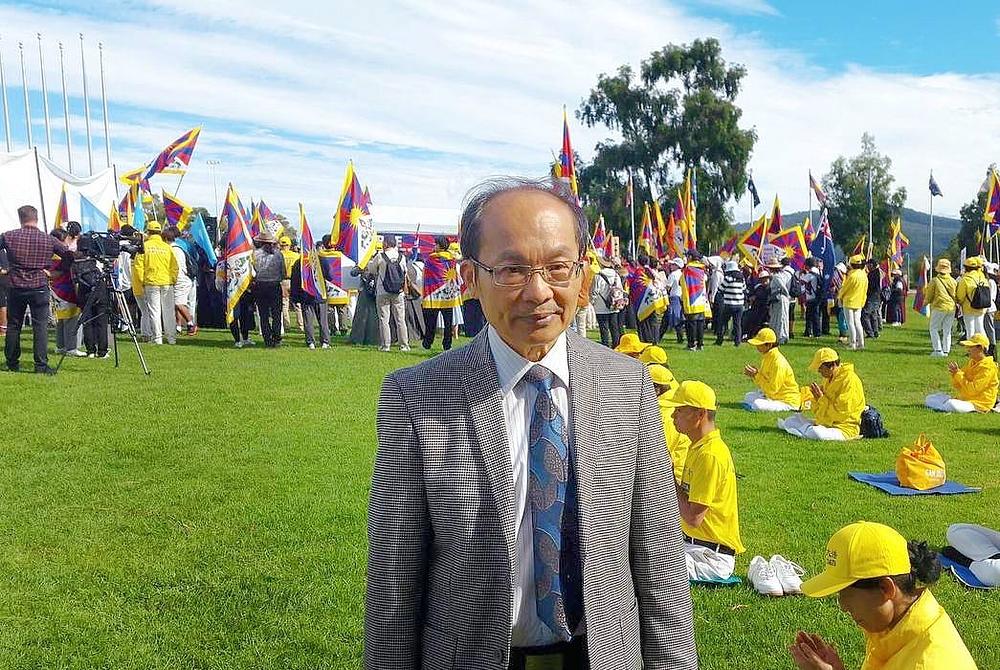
(487, 326), (572, 647)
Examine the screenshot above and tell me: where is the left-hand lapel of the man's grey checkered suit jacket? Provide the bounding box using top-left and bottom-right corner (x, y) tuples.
(462, 329), (517, 574)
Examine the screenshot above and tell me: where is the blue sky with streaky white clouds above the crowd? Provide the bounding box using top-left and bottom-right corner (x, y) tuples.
(0, 0), (1000, 227)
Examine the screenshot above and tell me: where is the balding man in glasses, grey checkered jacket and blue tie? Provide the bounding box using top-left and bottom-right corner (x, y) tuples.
(365, 178), (697, 670)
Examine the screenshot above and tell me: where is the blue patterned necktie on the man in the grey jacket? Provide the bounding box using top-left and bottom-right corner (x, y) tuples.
(524, 365), (580, 640)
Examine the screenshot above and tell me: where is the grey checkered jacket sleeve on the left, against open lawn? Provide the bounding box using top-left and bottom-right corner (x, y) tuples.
(364, 375), (431, 670)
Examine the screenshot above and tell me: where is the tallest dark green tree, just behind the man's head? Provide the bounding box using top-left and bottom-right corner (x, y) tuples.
(576, 39), (757, 252)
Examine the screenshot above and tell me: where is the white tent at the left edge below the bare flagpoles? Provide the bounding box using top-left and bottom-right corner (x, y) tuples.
(0, 150), (118, 233)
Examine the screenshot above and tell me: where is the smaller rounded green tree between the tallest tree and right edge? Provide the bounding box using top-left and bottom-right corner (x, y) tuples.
(823, 133), (906, 251)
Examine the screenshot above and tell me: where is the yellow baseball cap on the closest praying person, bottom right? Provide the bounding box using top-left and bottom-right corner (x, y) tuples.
(802, 521), (910, 598)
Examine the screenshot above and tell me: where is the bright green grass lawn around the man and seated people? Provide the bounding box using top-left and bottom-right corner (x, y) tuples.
(0, 317), (1000, 669)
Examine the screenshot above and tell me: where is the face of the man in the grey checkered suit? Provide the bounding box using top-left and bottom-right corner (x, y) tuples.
(462, 190), (583, 355)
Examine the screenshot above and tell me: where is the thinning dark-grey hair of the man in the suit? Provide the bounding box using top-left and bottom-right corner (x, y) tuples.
(459, 177), (590, 258)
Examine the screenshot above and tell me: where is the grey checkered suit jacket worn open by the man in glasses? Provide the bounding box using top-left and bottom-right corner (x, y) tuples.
(365, 330), (697, 670)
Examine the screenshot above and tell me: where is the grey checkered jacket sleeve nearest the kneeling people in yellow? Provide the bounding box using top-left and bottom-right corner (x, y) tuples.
(629, 373), (698, 670)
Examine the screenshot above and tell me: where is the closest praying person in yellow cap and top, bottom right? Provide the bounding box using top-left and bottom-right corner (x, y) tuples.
(788, 521), (976, 670)
